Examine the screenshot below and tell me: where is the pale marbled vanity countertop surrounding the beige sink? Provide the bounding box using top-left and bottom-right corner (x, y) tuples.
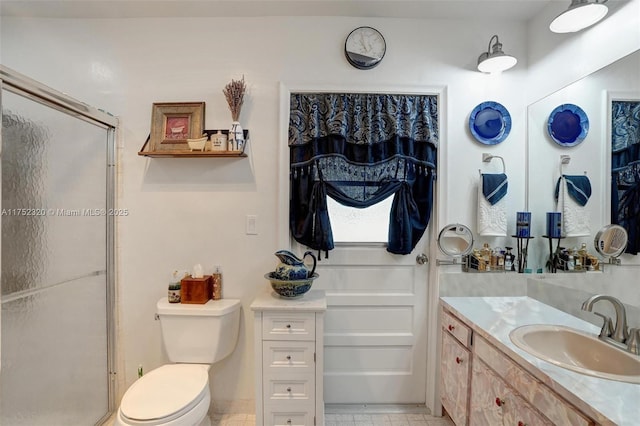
(440, 297), (640, 426)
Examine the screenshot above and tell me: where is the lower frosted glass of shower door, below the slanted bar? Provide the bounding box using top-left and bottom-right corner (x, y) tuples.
(0, 275), (108, 426)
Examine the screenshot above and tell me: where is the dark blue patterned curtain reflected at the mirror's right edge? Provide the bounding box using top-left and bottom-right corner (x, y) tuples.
(611, 101), (640, 254)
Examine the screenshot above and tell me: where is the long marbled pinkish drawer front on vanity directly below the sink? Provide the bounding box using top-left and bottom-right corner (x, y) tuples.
(473, 337), (592, 426)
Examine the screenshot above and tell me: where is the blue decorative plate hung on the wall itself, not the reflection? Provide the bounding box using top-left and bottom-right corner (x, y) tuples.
(469, 102), (511, 145)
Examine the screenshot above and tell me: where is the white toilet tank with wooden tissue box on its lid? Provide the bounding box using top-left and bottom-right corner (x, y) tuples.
(156, 297), (240, 364)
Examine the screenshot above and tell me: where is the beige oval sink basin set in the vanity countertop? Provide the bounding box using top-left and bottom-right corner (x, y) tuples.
(509, 324), (640, 383)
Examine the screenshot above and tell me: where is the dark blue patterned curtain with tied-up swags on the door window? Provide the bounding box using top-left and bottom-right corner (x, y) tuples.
(289, 93), (439, 254)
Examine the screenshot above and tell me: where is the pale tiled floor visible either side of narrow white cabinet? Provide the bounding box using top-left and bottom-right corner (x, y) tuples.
(211, 413), (453, 426)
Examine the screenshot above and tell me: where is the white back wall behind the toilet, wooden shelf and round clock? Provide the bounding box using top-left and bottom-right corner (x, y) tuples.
(0, 0), (638, 410)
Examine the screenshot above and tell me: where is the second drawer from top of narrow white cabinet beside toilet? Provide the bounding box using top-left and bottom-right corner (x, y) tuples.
(262, 341), (315, 377)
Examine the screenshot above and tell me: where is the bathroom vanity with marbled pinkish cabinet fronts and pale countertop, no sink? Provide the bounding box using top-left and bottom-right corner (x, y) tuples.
(440, 297), (640, 426)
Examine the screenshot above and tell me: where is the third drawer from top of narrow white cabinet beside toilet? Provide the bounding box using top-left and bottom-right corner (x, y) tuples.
(264, 374), (315, 406)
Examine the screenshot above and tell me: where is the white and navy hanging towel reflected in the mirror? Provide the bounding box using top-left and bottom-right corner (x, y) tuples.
(555, 175), (591, 237)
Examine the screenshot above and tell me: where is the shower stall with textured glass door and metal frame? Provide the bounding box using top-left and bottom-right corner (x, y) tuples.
(0, 65), (118, 426)
